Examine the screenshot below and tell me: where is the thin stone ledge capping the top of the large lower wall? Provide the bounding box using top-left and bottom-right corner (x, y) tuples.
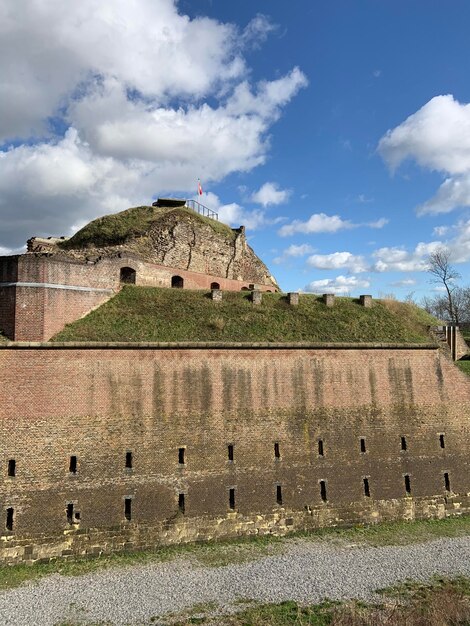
(0, 341), (439, 350)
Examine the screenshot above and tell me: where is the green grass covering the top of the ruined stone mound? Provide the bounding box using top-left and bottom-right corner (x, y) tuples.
(58, 206), (235, 250)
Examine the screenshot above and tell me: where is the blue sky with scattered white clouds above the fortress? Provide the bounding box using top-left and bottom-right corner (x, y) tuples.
(0, 0), (470, 301)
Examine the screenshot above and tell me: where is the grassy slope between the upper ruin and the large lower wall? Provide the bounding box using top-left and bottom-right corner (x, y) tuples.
(52, 286), (437, 343)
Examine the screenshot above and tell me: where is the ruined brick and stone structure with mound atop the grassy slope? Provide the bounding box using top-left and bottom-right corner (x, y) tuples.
(0, 206), (279, 341)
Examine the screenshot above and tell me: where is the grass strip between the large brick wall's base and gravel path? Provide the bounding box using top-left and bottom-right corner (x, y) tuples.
(0, 516), (470, 590)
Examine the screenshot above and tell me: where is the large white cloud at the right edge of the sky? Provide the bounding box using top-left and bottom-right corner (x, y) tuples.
(378, 95), (470, 215)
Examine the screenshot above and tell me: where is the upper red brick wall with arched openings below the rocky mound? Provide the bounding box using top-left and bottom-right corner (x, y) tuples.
(0, 254), (274, 341)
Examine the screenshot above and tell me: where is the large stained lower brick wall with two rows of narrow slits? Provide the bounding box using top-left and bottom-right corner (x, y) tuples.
(0, 344), (470, 561)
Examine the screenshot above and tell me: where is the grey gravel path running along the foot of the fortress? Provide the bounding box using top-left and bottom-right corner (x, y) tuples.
(0, 537), (470, 626)
